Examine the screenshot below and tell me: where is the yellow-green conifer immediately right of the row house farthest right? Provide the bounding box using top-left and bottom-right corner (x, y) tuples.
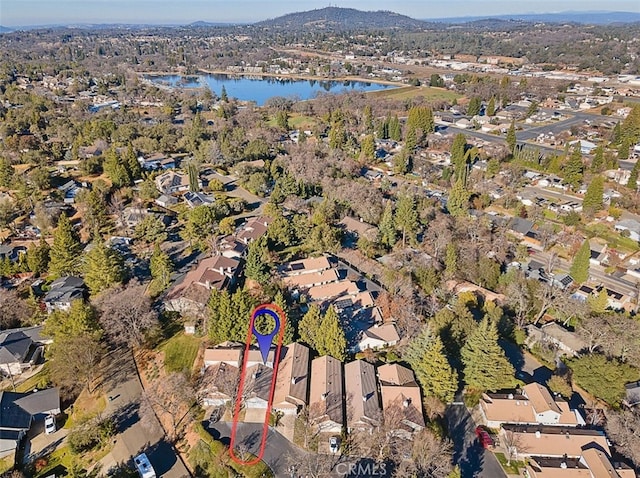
(404, 327), (458, 403)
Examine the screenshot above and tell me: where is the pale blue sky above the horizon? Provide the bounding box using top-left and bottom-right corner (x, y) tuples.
(0, 0), (640, 27)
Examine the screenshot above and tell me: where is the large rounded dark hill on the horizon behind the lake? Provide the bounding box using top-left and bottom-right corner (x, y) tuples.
(254, 7), (429, 30)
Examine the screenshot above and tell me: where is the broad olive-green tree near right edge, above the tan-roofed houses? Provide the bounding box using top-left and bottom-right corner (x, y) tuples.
(566, 354), (640, 407)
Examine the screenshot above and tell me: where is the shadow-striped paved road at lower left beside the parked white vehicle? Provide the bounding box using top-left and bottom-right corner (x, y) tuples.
(100, 349), (191, 478)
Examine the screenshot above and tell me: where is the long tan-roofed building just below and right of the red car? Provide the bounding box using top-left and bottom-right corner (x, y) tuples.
(500, 424), (611, 459)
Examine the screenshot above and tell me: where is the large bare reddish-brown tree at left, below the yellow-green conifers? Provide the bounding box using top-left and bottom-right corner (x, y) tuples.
(95, 281), (159, 347)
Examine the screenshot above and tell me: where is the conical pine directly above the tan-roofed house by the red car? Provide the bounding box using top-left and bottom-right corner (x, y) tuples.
(460, 318), (515, 391)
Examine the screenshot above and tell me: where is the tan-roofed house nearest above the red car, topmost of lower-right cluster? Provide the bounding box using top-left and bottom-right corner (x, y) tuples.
(479, 382), (585, 428)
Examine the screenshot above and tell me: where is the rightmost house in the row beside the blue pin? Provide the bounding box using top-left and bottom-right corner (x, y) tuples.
(377, 364), (426, 439)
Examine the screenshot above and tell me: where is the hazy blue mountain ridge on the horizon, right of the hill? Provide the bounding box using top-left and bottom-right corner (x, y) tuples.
(424, 11), (640, 25)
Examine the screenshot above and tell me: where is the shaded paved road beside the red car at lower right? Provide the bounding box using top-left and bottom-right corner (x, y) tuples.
(445, 403), (506, 478)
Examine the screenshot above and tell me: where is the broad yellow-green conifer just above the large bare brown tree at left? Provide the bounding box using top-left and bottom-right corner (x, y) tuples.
(83, 237), (124, 295)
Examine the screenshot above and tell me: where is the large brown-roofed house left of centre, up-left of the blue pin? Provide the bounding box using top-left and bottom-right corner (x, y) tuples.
(165, 255), (240, 313)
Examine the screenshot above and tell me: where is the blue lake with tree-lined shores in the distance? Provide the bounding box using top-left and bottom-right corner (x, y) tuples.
(145, 74), (396, 106)
